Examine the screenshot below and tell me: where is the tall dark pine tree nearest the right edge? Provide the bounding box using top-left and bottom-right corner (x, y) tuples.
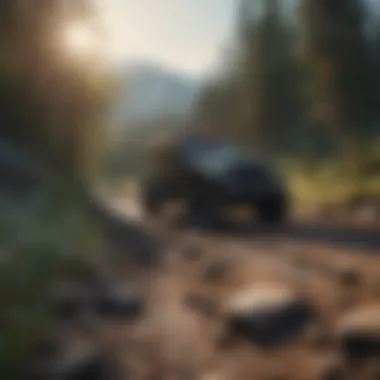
(301, 0), (374, 157)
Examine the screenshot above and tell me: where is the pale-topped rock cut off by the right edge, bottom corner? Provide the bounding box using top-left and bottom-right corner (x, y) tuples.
(336, 306), (380, 362)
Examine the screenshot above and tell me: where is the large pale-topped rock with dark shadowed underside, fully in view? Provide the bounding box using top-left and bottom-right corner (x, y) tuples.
(226, 284), (314, 348)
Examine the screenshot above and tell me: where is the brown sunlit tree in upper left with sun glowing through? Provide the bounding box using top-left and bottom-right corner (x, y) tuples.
(0, 0), (111, 181)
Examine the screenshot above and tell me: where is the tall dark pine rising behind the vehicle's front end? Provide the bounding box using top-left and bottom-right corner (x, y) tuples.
(238, 0), (296, 154)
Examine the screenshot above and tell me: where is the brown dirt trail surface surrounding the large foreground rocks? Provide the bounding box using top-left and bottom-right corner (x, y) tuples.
(28, 196), (380, 380)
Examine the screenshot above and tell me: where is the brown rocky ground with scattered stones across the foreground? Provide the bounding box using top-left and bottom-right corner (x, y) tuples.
(27, 197), (380, 380)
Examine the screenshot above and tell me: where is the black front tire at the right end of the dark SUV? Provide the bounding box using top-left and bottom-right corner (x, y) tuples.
(256, 196), (288, 225)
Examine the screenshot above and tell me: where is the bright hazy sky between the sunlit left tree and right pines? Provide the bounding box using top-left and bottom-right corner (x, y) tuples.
(97, 0), (237, 74)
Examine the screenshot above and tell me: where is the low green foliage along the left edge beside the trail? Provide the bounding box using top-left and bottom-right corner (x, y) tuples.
(0, 177), (100, 379)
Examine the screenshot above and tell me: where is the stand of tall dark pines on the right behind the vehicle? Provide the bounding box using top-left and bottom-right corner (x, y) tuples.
(193, 0), (380, 172)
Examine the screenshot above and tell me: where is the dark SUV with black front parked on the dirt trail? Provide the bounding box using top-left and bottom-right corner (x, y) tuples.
(142, 138), (288, 229)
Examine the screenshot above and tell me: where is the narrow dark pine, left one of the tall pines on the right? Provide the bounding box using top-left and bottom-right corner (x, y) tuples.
(247, 0), (295, 154)
